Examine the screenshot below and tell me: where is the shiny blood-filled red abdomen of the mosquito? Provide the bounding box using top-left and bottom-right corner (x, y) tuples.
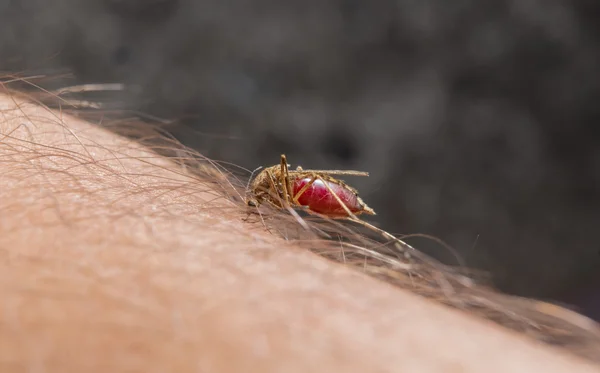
(293, 177), (363, 217)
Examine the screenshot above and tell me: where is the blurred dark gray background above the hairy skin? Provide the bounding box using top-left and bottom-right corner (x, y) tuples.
(0, 0), (600, 319)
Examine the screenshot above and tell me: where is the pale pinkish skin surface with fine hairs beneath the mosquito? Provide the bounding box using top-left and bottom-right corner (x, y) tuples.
(0, 91), (598, 373)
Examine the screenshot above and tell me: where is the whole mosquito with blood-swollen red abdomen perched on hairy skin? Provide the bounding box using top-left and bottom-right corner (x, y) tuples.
(246, 154), (414, 251)
